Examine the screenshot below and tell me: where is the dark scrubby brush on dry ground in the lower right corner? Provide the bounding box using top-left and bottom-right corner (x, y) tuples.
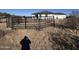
(49, 33), (79, 50)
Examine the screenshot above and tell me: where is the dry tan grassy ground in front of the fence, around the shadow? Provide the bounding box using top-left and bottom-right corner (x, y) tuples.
(0, 23), (79, 50)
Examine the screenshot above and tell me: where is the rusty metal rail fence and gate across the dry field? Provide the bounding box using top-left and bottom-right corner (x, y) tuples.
(6, 16), (55, 30)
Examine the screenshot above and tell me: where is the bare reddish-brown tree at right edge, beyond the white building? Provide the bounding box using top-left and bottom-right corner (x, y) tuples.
(66, 11), (79, 34)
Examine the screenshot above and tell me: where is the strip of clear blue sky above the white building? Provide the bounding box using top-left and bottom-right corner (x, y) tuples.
(0, 9), (79, 16)
